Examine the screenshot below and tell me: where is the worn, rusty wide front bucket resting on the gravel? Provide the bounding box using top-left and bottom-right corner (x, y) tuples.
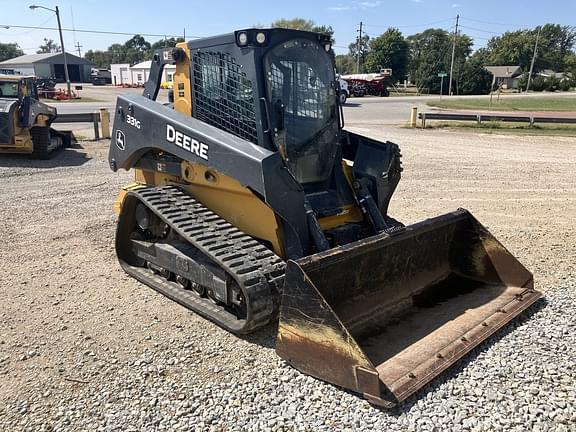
(276, 209), (541, 407)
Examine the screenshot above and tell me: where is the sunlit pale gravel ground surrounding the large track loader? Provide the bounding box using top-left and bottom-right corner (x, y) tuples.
(0, 128), (576, 431)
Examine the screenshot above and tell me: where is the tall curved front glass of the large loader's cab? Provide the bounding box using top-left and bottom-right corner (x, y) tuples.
(265, 39), (338, 183)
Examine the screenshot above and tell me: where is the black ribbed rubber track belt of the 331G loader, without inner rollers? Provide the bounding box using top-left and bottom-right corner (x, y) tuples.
(121, 186), (286, 333)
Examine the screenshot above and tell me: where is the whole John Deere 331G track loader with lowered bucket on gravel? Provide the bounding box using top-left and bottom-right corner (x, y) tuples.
(109, 29), (539, 406)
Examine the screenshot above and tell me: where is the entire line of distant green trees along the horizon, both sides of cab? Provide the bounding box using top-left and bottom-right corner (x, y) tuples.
(0, 18), (576, 94)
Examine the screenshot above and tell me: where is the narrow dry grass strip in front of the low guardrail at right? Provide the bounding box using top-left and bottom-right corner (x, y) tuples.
(426, 122), (576, 137)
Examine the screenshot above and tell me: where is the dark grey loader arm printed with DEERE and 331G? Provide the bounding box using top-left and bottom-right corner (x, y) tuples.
(109, 95), (310, 258)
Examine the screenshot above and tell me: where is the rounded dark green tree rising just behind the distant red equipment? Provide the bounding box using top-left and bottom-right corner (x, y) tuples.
(366, 28), (409, 81)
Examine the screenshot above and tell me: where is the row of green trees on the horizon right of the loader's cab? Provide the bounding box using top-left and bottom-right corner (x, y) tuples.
(336, 24), (576, 94)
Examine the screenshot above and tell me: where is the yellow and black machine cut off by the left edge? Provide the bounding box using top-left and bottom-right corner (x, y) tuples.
(0, 75), (70, 159)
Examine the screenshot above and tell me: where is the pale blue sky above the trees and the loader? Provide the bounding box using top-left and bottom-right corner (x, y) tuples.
(0, 0), (576, 54)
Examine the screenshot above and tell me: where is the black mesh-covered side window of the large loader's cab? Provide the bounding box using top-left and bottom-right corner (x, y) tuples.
(193, 51), (258, 143)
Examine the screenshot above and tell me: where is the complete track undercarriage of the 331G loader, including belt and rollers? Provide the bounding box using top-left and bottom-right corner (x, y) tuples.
(116, 186), (285, 333)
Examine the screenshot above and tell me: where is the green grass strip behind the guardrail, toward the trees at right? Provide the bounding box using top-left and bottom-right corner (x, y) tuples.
(427, 96), (576, 112)
